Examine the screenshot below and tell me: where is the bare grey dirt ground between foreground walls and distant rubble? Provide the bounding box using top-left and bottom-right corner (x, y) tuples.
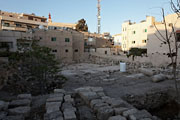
(61, 63), (179, 98)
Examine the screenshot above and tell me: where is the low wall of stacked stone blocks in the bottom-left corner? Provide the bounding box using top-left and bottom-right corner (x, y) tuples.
(0, 94), (32, 120)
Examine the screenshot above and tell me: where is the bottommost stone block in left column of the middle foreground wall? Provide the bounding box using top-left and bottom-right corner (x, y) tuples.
(44, 111), (63, 120)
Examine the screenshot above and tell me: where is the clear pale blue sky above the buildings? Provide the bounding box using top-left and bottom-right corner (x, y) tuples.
(0, 0), (174, 35)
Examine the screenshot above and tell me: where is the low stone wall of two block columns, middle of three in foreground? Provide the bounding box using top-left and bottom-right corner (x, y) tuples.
(44, 89), (76, 120)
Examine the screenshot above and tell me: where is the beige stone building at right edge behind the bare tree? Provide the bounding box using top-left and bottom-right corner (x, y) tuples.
(147, 14), (180, 65)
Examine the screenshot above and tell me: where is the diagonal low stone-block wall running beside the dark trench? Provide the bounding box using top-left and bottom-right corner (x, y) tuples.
(75, 87), (158, 120)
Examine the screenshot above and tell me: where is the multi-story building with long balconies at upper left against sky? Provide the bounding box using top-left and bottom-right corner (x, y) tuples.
(0, 11), (48, 32)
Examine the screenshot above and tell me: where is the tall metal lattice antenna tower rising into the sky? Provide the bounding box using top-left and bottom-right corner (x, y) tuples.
(97, 0), (101, 34)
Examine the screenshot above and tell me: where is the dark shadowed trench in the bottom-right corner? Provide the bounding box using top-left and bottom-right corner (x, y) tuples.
(124, 91), (180, 120)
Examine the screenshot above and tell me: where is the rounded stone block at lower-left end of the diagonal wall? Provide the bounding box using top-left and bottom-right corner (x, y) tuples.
(97, 106), (114, 120)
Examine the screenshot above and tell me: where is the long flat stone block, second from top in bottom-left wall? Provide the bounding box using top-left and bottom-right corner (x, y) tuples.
(9, 99), (31, 108)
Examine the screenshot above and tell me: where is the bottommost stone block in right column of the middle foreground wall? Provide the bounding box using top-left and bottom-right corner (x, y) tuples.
(63, 109), (77, 120)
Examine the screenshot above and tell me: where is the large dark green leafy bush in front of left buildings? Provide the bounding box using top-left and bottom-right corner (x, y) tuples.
(9, 41), (64, 94)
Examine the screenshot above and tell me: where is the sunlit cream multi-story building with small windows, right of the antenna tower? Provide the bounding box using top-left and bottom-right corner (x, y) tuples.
(122, 16), (158, 51)
